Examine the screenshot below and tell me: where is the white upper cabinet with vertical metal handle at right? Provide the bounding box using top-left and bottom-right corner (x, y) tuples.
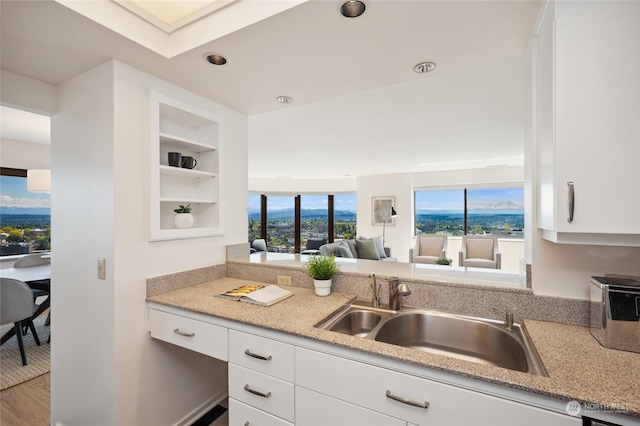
(533, 1), (640, 246)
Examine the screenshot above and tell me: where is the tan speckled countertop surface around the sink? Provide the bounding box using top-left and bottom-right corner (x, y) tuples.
(147, 278), (640, 417)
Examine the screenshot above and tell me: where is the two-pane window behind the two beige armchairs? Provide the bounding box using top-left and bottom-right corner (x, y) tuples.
(414, 187), (524, 238)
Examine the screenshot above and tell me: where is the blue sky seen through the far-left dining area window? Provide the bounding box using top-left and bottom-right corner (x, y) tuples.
(0, 176), (51, 214)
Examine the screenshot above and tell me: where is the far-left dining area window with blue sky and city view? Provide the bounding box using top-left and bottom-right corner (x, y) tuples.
(0, 168), (51, 256)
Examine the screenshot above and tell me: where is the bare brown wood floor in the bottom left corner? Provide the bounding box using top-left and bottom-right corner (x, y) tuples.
(0, 373), (51, 426)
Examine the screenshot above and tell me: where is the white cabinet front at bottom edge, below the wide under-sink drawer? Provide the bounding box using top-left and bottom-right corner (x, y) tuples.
(296, 386), (407, 426)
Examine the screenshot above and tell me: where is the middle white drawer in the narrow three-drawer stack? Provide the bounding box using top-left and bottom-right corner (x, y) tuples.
(229, 363), (294, 422)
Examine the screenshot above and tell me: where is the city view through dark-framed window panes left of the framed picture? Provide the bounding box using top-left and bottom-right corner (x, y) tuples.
(249, 194), (356, 253)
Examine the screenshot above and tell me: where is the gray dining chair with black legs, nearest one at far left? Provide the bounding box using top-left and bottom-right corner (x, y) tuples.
(0, 278), (40, 365)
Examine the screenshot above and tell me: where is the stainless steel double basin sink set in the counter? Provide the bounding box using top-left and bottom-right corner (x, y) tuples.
(316, 302), (548, 376)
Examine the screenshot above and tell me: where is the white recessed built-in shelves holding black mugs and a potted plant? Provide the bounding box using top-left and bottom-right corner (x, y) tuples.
(149, 92), (223, 241)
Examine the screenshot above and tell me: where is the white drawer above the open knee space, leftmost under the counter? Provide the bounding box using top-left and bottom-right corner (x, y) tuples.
(149, 309), (228, 361)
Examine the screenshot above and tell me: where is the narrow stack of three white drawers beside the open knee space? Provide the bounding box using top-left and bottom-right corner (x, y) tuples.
(229, 330), (294, 424)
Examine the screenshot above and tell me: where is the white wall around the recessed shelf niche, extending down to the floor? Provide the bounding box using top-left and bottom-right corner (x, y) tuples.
(51, 62), (247, 426)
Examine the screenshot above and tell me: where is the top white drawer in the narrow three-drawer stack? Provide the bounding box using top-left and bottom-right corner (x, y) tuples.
(229, 330), (294, 382)
